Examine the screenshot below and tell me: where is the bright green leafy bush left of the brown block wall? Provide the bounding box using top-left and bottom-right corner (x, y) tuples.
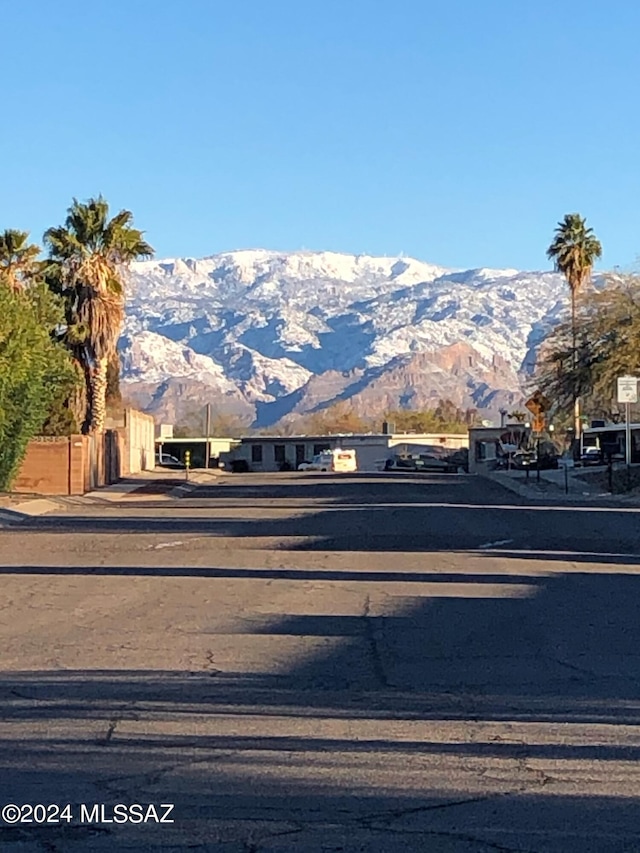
(0, 286), (75, 490)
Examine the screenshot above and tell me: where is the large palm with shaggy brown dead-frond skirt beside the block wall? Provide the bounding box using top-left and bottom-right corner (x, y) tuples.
(44, 196), (153, 432)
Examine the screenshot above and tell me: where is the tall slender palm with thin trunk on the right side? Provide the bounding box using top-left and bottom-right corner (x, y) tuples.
(547, 213), (602, 438)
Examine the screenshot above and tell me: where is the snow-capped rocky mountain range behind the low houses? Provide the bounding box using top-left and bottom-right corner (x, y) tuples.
(121, 250), (568, 426)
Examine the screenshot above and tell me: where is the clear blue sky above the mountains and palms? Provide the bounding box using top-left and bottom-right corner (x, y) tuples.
(0, 0), (640, 269)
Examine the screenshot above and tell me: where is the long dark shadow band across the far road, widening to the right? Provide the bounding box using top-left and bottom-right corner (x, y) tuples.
(12, 499), (640, 560)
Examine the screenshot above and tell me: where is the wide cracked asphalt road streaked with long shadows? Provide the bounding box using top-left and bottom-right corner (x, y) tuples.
(0, 474), (640, 853)
